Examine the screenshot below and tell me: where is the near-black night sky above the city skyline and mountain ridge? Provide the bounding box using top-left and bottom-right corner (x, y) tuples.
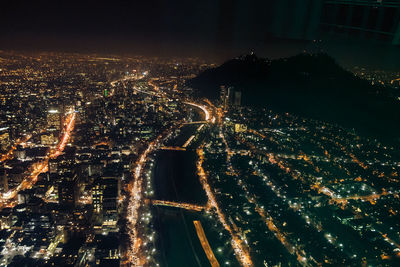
(0, 0), (400, 65)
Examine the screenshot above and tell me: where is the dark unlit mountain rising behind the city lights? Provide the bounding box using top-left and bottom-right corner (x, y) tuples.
(188, 54), (400, 146)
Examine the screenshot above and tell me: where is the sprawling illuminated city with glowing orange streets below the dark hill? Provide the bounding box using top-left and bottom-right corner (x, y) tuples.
(0, 49), (400, 266)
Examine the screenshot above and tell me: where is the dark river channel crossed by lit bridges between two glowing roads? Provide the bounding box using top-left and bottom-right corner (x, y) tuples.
(153, 125), (210, 267)
